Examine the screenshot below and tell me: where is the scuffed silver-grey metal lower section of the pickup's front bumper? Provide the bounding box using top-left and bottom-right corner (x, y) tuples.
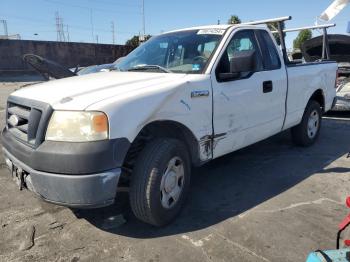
(2, 148), (121, 208)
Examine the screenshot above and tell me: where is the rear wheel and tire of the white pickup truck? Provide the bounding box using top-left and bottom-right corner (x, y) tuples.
(292, 100), (322, 147)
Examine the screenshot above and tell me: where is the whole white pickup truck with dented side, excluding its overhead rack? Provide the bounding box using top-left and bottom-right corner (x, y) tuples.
(2, 19), (337, 226)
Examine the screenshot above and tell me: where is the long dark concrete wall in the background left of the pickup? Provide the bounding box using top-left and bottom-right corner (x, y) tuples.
(0, 40), (132, 73)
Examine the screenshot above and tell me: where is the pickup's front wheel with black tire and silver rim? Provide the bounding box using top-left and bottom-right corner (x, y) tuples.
(129, 138), (191, 227)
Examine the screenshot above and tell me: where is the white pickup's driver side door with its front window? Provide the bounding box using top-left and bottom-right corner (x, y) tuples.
(212, 29), (285, 158)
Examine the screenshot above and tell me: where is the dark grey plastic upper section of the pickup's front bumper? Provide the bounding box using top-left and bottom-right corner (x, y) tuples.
(1, 128), (130, 175)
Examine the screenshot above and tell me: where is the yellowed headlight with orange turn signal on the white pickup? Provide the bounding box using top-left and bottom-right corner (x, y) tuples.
(45, 111), (108, 142)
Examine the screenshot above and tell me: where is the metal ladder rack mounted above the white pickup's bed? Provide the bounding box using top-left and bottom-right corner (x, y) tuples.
(238, 16), (336, 64)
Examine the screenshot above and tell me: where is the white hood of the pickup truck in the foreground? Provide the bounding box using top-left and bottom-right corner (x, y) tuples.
(12, 71), (186, 110)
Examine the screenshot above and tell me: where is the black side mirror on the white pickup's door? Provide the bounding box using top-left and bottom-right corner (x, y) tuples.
(218, 50), (256, 82)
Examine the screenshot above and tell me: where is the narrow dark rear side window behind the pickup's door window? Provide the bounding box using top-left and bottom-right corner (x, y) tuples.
(257, 30), (281, 70)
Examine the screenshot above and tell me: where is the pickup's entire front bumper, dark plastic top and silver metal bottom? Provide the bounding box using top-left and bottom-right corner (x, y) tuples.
(1, 128), (130, 208)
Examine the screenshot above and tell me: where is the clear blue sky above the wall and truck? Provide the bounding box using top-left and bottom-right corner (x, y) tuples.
(0, 0), (350, 47)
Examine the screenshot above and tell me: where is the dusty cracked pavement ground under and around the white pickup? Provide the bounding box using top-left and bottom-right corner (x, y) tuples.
(0, 83), (350, 262)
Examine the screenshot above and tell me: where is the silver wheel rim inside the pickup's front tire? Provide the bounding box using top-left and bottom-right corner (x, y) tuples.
(160, 157), (184, 209)
